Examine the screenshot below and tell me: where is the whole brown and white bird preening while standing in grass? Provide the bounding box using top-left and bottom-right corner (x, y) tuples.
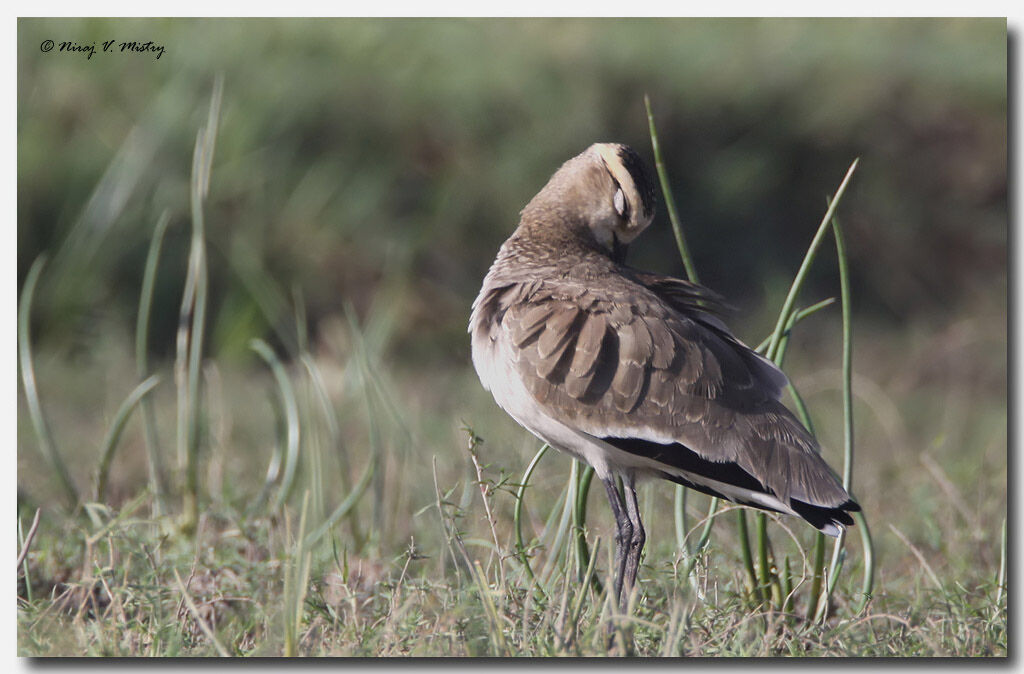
(468, 142), (860, 612)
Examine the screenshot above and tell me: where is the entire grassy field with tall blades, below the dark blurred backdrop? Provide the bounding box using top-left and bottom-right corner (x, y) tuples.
(17, 78), (1008, 657)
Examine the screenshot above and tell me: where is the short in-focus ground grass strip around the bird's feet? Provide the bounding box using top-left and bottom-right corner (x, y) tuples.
(18, 403), (1007, 656)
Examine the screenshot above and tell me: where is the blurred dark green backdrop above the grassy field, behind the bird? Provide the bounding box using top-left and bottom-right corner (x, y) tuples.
(17, 19), (1007, 363)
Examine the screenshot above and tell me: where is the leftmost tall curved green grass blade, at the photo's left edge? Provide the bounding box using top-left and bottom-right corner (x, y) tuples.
(17, 254), (79, 510)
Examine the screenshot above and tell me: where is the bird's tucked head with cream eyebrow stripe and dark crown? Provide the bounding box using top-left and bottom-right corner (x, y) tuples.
(523, 142), (654, 261)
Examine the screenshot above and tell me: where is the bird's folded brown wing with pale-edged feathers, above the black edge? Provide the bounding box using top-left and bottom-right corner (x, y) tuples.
(491, 270), (850, 508)
